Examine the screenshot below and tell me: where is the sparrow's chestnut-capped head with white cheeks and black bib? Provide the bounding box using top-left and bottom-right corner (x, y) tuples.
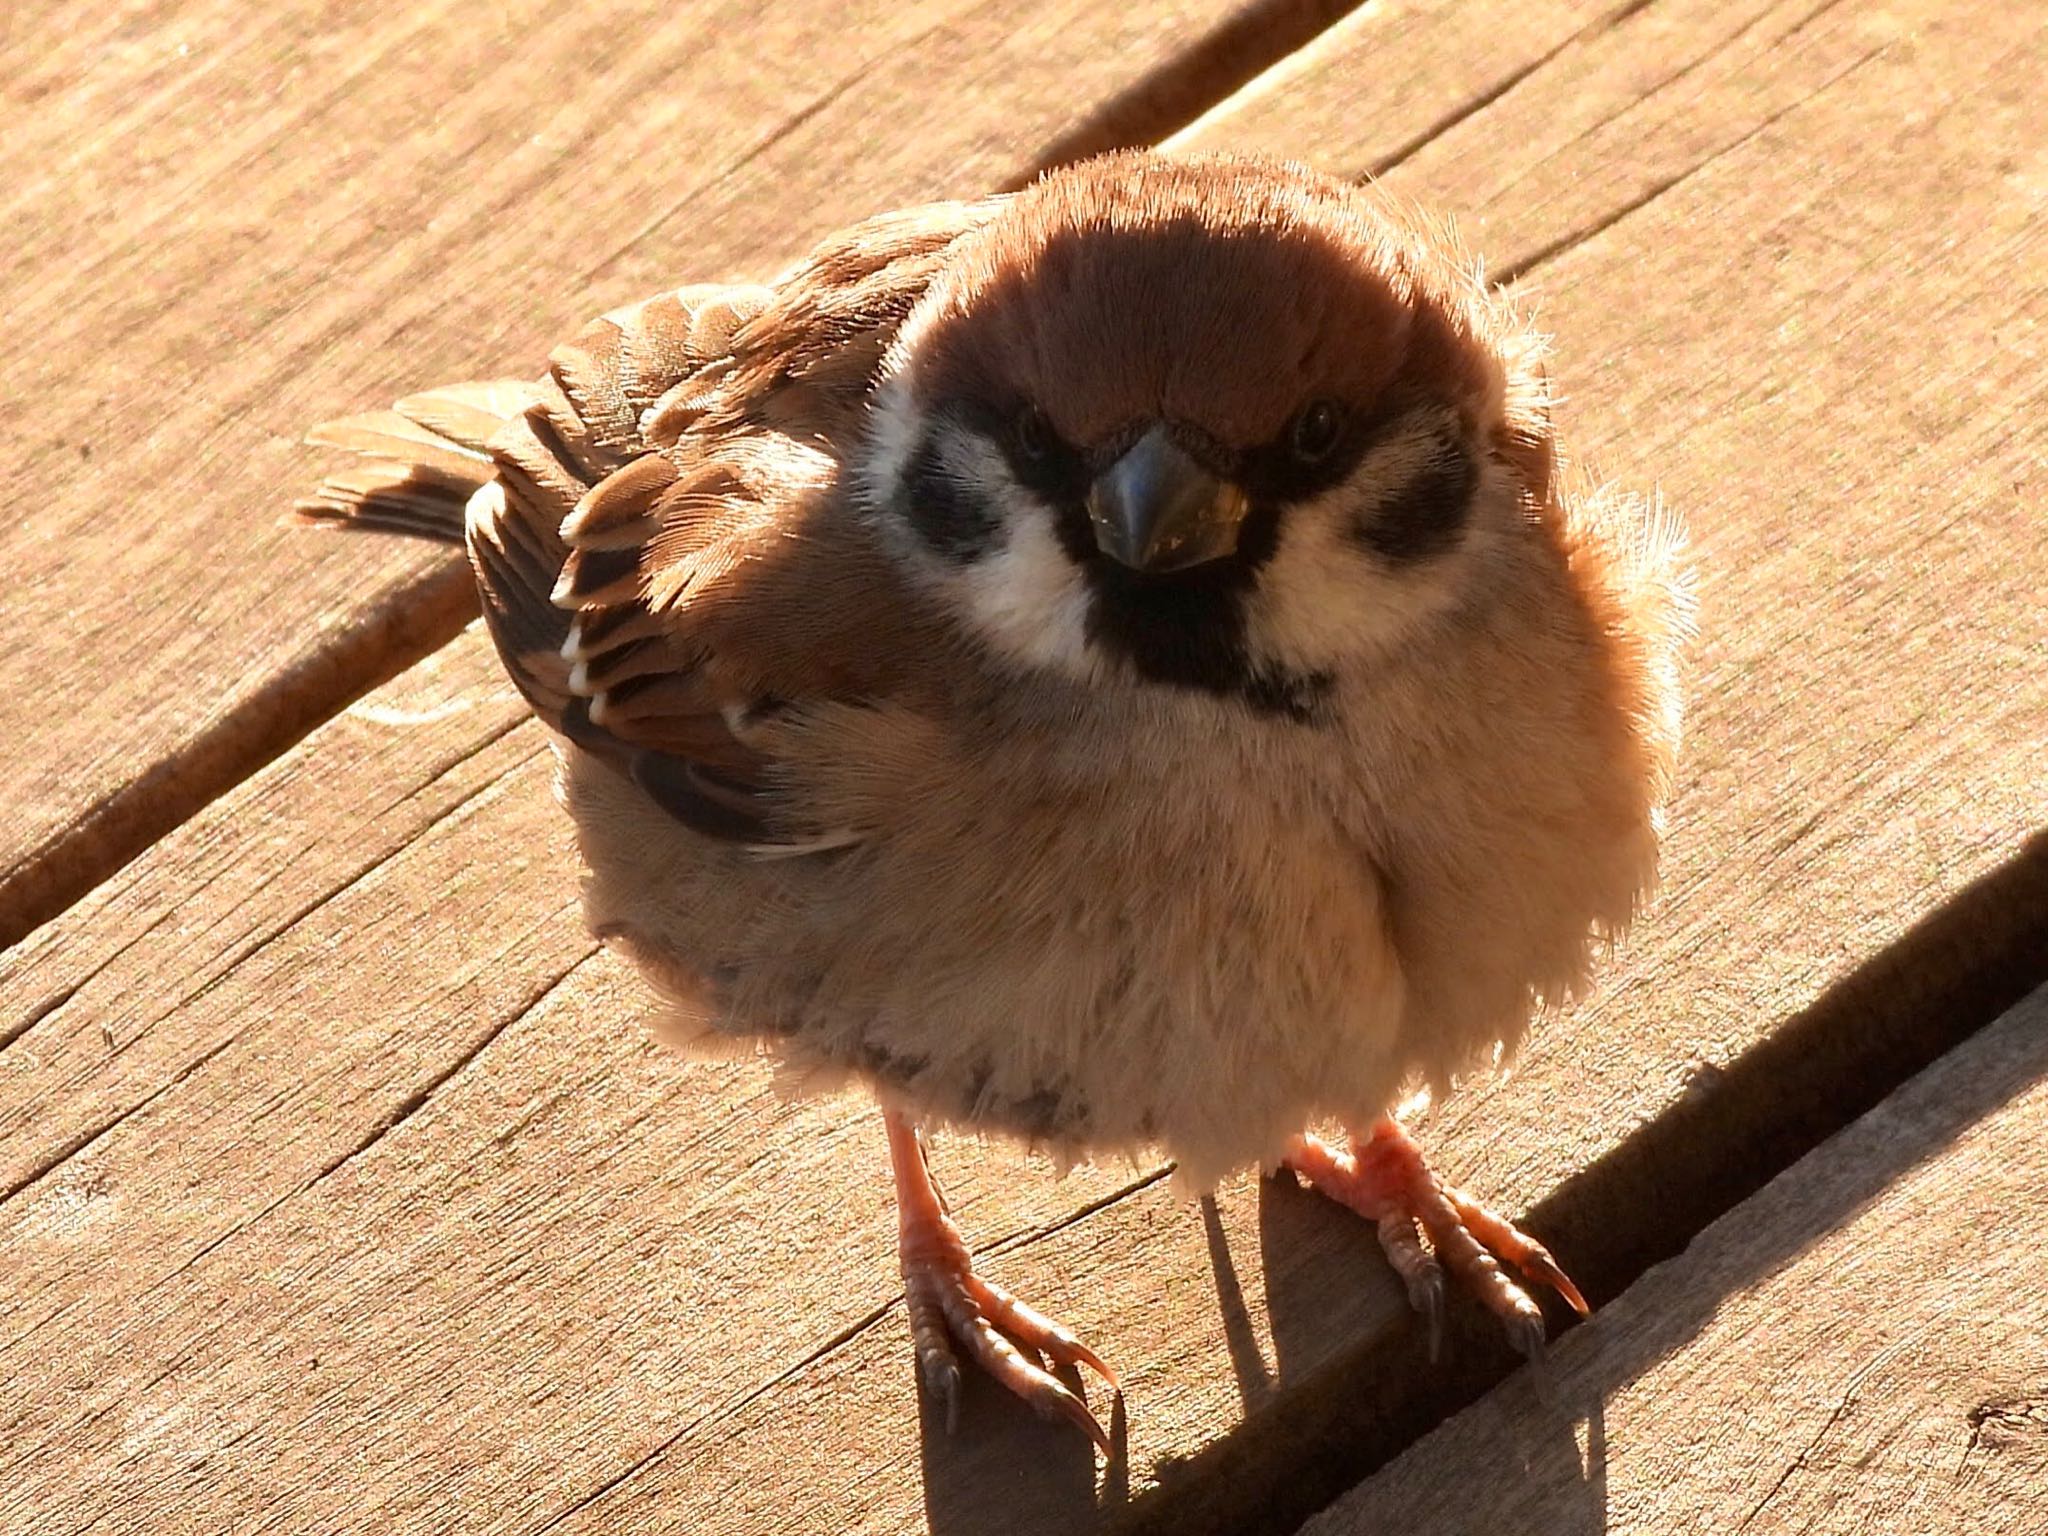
(860, 154), (1550, 713)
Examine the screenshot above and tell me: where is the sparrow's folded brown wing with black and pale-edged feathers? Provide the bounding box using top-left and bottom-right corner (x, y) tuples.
(467, 203), (993, 844)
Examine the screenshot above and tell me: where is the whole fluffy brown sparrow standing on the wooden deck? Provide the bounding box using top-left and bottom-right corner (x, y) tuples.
(301, 154), (1688, 1446)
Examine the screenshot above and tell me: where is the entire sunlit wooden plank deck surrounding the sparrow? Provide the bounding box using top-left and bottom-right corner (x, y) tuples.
(0, 0), (2048, 1536)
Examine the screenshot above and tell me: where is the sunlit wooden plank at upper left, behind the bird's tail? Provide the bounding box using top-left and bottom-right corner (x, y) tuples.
(0, 0), (1376, 946)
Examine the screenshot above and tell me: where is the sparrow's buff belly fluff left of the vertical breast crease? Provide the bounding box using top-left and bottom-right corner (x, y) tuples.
(565, 696), (1405, 1180)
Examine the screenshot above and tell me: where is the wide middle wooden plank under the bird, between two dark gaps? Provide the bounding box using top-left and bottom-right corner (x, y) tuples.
(0, 4), (2048, 1532)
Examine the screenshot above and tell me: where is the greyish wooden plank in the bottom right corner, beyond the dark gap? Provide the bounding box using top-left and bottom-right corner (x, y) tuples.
(1303, 993), (2048, 1536)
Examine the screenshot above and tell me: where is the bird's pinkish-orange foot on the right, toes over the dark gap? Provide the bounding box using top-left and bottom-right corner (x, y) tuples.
(1286, 1116), (1591, 1360)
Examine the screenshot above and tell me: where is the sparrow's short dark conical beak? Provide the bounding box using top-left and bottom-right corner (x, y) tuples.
(1087, 426), (1245, 573)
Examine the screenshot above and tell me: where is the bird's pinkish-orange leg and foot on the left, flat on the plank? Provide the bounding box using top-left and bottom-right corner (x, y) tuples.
(883, 1112), (1120, 1456)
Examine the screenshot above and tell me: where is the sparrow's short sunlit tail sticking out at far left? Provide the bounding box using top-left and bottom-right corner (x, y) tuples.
(293, 379), (537, 545)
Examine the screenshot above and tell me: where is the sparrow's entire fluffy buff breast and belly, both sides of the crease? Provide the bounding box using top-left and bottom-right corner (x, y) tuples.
(565, 493), (1669, 1184)
